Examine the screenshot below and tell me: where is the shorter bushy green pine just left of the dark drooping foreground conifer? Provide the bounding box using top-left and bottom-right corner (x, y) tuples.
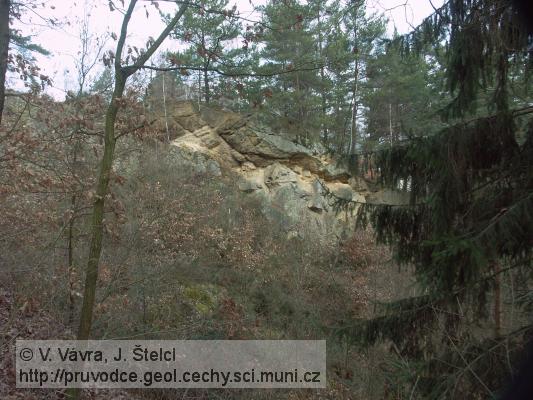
(361, 39), (448, 152)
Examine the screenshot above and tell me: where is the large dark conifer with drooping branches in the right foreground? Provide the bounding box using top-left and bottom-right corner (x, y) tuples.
(337, 0), (533, 399)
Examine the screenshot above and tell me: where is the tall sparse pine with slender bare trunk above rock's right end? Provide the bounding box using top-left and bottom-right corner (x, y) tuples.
(316, 0), (385, 156)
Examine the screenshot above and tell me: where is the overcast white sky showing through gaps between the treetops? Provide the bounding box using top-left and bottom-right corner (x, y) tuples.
(10, 0), (443, 99)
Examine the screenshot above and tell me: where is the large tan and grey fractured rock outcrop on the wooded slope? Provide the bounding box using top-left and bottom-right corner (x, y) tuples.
(165, 102), (367, 238)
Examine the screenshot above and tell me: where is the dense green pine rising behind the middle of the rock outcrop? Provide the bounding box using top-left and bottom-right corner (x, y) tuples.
(254, 0), (320, 144)
